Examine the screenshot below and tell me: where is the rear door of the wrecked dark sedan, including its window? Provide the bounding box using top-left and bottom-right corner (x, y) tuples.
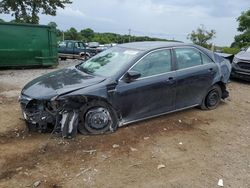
(174, 47), (218, 109)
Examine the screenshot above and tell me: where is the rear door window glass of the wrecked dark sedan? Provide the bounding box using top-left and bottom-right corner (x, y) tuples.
(175, 48), (202, 69)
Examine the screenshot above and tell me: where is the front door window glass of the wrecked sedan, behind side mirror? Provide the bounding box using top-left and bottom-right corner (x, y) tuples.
(131, 49), (171, 78)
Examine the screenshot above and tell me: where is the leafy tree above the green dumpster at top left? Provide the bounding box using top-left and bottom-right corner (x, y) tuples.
(0, 0), (72, 24)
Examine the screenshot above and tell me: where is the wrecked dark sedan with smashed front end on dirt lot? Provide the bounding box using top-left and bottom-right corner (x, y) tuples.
(19, 42), (231, 138)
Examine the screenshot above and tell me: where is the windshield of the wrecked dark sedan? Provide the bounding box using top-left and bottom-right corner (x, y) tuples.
(78, 47), (140, 77)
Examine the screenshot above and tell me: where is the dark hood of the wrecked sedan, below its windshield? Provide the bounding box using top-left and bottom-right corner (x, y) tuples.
(22, 67), (105, 99)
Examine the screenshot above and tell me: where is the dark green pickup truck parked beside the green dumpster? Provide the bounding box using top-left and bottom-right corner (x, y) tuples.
(58, 40), (102, 60)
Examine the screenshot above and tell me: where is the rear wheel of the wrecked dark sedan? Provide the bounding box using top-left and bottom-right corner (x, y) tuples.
(200, 84), (222, 110)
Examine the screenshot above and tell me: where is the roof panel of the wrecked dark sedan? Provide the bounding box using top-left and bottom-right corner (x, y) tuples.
(119, 41), (188, 51)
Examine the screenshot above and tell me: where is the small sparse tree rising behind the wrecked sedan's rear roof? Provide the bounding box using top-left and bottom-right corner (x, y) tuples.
(187, 25), (216, 48)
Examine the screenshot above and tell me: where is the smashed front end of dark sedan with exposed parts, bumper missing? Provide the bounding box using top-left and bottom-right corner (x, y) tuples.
(19, 94), (86, 138)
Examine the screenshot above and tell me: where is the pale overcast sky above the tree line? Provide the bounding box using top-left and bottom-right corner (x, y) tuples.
(1, 0), (250, 45)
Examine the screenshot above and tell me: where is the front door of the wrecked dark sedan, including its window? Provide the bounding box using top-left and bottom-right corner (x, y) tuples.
(116, 49), (176, 122)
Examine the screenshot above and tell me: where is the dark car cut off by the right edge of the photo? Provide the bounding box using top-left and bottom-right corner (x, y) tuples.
(231, 47), (250, 81)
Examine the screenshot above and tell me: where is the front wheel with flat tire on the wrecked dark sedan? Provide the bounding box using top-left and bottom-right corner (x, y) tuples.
(78, 100), (119, 135)
